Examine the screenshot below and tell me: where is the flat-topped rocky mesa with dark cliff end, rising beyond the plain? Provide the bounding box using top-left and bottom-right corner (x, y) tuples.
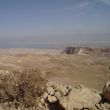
(63, 46), (110, 57)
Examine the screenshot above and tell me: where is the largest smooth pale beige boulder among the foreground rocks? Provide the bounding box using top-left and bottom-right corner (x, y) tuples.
(59, 88), (101, 110)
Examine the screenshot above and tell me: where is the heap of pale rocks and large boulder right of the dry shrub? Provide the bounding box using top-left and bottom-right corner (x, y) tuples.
(40, 82), (110, 110)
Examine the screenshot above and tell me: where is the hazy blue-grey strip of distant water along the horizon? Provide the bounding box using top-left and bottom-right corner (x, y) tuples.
(0, 41), (110, 49)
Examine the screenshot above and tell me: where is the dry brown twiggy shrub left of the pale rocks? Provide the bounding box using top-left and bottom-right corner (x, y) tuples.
(0, 69), (46, 108)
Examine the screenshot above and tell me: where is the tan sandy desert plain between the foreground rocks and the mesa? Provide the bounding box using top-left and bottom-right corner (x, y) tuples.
(0, 49), (110, 89)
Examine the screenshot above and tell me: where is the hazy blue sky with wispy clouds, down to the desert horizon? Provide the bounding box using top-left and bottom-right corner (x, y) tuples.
(0, 0), (110, 48)
